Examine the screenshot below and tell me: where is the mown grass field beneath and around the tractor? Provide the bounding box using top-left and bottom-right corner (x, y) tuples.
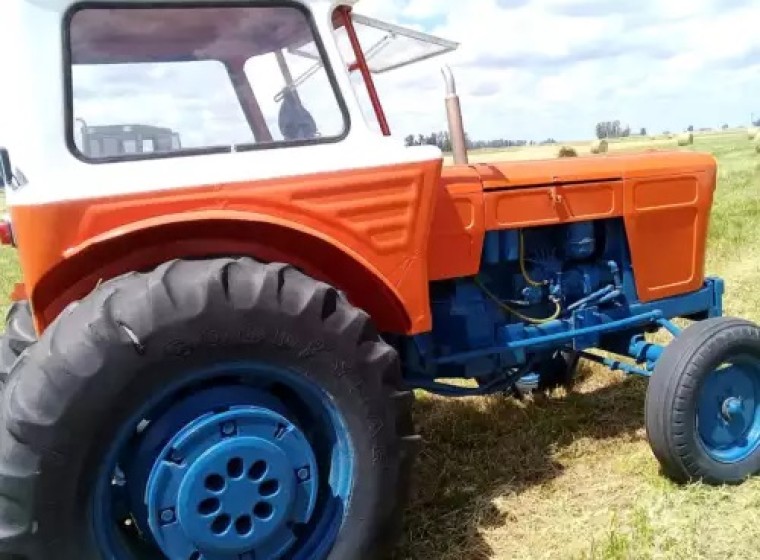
(0, 129), (760, 560)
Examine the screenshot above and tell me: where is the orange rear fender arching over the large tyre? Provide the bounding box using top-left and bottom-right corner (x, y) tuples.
(11, 160), (441, 332)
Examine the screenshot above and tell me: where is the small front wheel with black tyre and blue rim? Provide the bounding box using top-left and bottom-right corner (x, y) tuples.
(646, 317), (760, 484)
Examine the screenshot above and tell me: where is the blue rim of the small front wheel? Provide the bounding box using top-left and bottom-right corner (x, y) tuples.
(696, 357), (760, 463)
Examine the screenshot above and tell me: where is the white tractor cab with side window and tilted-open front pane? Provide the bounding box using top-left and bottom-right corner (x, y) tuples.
(0, 0), (457, 204)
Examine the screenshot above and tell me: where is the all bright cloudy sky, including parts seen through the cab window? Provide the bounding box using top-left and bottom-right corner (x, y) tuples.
(0, 0), (760, 146)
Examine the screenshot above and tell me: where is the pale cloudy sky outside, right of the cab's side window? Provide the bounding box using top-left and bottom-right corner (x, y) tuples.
(355, 0), (760, 141)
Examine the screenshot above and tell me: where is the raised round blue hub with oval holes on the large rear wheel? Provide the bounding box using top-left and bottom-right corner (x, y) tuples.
(145, 406), (318, 560)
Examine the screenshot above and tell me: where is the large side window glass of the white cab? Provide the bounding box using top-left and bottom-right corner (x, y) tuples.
(67, 2), (348, 160)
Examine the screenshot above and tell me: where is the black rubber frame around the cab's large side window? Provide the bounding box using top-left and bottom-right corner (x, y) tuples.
(62, 0), (353, 165)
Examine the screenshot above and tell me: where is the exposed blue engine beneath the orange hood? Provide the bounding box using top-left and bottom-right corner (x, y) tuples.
(403, 218), (637, 380)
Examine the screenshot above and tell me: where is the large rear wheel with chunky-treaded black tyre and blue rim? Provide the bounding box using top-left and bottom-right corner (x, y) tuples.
(0, 259), (417, 560)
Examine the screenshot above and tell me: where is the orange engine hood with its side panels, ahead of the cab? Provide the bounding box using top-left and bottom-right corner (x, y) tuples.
(475, 152), (717, 302)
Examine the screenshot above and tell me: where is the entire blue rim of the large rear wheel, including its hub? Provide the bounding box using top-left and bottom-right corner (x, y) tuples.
(91, 364), (353, 560)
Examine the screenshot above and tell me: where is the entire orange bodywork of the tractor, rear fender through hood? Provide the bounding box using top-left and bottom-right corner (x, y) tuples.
(7, 148), (716, 334)
